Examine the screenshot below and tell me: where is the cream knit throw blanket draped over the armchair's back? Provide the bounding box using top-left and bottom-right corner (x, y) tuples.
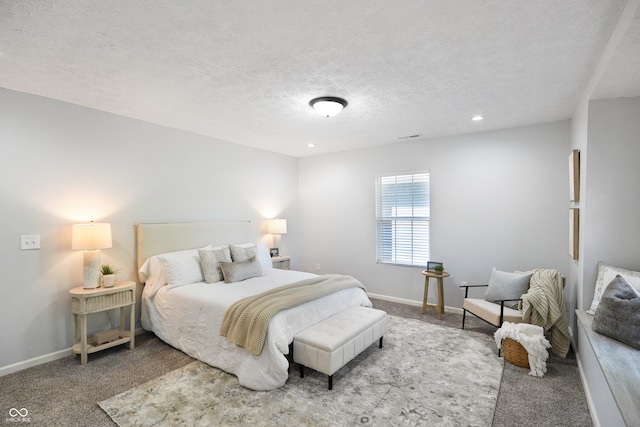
(522, 269), (570, 357)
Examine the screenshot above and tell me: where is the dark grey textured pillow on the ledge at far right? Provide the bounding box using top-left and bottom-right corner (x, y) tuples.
(591, 274), (640, 350)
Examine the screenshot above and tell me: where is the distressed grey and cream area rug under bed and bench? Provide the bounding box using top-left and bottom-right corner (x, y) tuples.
(98, 316), (503, 427)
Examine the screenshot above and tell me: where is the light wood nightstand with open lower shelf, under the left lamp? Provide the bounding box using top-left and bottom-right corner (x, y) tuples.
(69, 281), (136, 365)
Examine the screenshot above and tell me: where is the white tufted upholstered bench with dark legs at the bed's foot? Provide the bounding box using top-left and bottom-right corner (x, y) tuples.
(293, 307), (387, 390)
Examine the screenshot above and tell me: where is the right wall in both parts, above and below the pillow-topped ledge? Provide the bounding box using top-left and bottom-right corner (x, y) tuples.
(572, 97), (640, 426)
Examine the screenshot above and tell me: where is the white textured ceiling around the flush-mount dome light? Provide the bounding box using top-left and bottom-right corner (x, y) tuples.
(0, 0), (640, 157)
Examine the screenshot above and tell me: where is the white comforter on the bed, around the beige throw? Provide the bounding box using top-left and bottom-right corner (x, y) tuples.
(141, 269), (371, 390)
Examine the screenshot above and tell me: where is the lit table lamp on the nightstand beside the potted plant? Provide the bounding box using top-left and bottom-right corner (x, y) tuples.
(71, 221), (111, 289)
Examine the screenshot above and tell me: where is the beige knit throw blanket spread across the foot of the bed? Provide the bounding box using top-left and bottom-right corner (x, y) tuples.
(220, 274), (366, 356)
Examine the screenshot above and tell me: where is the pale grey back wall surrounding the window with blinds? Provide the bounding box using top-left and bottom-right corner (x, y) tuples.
(299, 121), (571, 307)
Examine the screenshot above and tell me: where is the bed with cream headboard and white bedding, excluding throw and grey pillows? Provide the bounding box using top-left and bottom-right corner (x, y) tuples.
(136, 221), (371, 390)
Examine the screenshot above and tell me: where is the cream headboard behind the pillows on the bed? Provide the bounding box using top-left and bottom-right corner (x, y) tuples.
(136, 221), (251, 269)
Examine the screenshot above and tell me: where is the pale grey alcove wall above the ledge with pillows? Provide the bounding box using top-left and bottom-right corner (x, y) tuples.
(579, 97), (640, 310)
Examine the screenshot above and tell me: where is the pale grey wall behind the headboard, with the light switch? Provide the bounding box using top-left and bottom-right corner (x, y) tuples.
(0, 89), (299, 368)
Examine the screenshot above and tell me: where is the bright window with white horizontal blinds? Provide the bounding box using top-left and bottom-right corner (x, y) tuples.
(376, 172), (431, 266)
